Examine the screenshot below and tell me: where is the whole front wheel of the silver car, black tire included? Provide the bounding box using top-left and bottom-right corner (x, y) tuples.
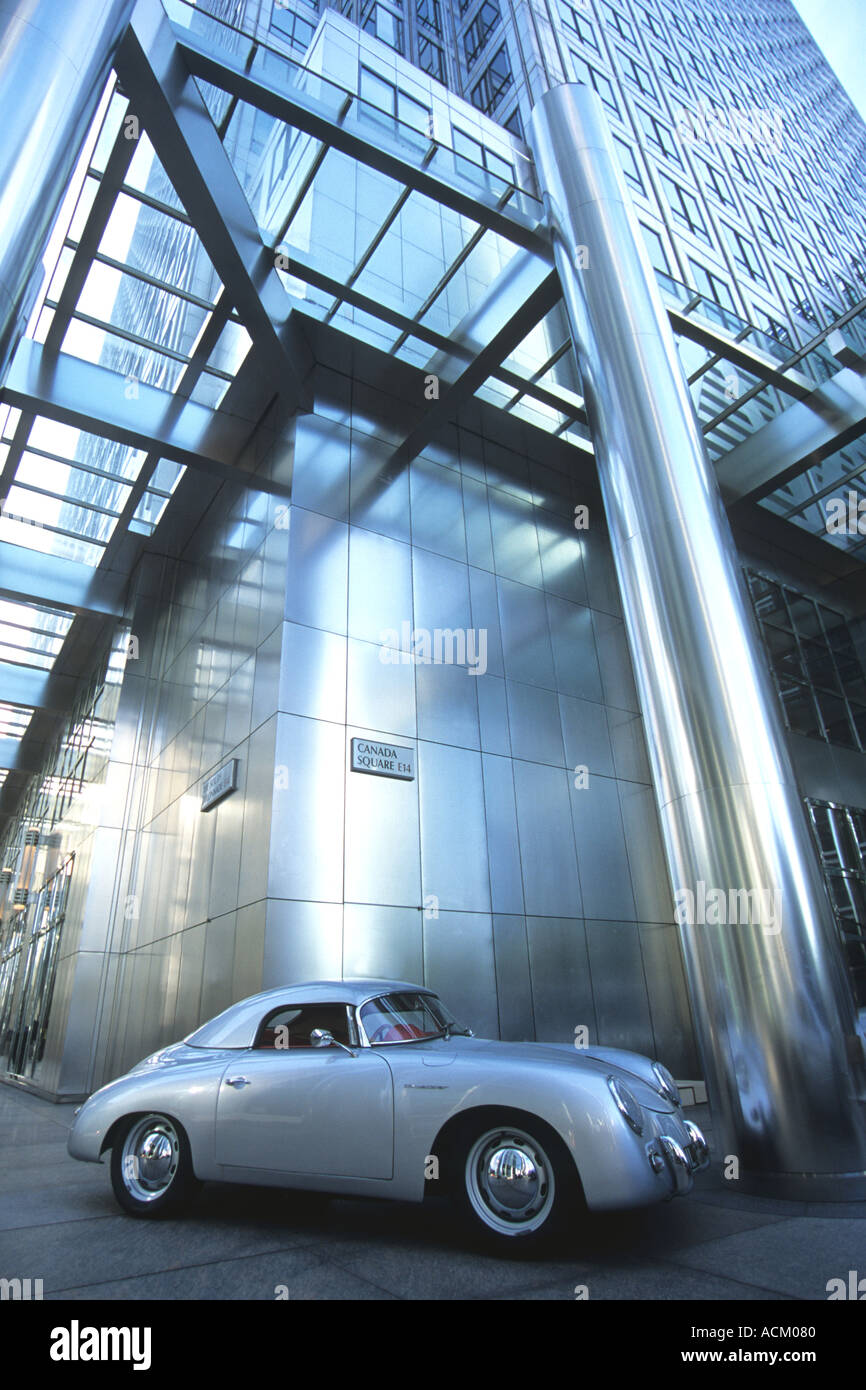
(449, 1113), (585, 1255)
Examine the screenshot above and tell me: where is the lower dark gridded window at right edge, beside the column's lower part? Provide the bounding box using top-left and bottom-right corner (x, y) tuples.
(806, 799), (866, 1009)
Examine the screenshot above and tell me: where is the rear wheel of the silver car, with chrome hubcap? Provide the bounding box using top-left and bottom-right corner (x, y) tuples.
(111, 1113), (202, 1219)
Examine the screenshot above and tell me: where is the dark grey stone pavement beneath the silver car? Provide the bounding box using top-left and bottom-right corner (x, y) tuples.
(0, 1084), (866, 1301)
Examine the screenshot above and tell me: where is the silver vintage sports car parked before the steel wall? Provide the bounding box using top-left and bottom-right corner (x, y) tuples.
(70, 980), (709, 1248)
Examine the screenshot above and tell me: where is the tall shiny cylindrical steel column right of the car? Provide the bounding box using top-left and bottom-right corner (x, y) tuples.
(530, 83), (866, 1195)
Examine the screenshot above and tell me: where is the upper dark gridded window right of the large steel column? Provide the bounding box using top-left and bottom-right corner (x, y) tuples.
(748, 571), (866, 752)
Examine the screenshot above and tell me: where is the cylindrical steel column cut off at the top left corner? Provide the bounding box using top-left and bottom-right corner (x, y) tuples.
(0, 0), (135, 379)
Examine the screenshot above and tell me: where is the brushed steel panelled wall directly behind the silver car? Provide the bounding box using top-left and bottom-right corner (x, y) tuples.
(69, 339), (696, 1090)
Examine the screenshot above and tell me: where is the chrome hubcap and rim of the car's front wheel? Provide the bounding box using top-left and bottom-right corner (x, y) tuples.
(464, 1129), (555, 1236)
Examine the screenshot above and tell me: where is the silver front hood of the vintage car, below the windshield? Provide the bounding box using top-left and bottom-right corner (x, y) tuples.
(411, 1036), (677, 1115)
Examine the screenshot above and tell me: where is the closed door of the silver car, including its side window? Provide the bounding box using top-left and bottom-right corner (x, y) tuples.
(215, 1004), (393, 1179)
